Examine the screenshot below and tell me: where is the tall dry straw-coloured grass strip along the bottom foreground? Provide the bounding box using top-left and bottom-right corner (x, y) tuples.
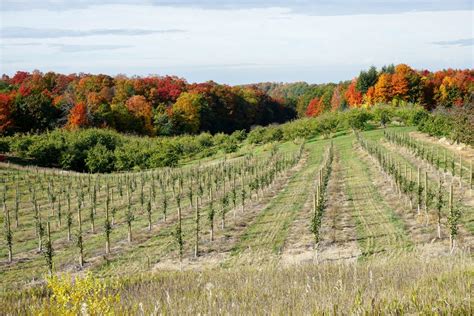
(0, 251), (474, 315)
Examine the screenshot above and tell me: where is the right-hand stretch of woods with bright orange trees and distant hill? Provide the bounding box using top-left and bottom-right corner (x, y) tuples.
(252, 64), (474, 117)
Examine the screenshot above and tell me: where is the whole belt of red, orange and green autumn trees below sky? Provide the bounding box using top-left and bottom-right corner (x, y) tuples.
(0, 64), (474, 135)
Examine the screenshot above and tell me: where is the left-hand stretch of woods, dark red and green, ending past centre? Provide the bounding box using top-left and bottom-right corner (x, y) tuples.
(0, 71), (295, 136)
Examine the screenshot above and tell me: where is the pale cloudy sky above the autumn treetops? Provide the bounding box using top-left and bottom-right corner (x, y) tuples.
(0, 0), (474, 84)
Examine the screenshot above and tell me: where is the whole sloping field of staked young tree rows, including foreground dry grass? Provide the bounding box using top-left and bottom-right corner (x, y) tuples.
(0, 127), (474, 315)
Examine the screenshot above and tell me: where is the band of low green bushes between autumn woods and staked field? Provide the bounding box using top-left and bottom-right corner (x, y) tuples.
(2, 105), (450, 172)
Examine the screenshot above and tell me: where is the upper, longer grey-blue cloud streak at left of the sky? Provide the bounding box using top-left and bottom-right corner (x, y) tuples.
(1, 27), (185, 38)
